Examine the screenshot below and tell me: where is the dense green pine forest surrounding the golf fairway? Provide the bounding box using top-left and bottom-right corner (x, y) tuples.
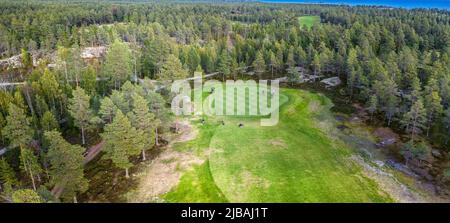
(0, 0), (450, 202)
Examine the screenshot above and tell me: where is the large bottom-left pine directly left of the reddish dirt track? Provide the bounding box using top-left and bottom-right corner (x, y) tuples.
(44, 130), (88, 202)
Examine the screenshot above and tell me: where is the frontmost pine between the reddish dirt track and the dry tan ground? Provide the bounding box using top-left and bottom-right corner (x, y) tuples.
(101, 110), (145, 178)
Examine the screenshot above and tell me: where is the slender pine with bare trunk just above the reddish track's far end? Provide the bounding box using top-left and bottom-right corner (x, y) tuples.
(69, 87), (100, 145)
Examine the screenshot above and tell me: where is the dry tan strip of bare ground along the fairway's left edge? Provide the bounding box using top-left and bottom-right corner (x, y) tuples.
(128, 121), (204, 202)
